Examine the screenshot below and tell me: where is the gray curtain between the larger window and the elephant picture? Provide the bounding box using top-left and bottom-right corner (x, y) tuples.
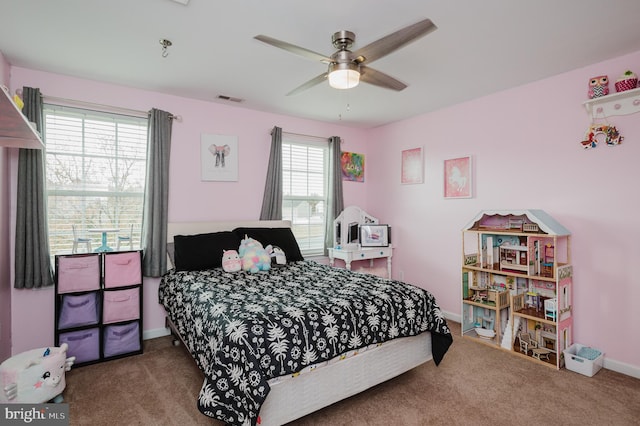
(140, 108), (173, 277)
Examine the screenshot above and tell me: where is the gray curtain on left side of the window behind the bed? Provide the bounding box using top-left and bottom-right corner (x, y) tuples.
(260, 127), (282, 220)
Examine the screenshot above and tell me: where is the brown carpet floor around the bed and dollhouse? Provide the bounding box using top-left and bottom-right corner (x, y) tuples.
(63, 322), (640, 426)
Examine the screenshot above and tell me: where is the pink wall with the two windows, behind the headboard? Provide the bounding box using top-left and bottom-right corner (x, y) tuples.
(3, 67), (368, 354)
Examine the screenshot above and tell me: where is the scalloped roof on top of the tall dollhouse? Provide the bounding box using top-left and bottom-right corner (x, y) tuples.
(464, 209), (571, 236)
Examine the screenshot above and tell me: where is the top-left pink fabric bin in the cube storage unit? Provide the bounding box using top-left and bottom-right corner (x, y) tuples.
(57, 254), (100, 293)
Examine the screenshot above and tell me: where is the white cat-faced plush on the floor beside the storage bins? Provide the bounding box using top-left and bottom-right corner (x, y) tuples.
(0, 343), (76, 403)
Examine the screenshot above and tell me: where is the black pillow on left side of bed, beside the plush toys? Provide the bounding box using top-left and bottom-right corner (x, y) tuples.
(173, 231), (240, 271)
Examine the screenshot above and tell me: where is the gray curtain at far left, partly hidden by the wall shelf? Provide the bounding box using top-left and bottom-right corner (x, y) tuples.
(14, 87), (53, 288)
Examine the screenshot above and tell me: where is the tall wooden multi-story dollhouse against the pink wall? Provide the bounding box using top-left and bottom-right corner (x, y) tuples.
(462, 210), (573, 369)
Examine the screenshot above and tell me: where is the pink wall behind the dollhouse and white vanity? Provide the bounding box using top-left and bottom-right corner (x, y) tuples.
(367, 52), (640, 377)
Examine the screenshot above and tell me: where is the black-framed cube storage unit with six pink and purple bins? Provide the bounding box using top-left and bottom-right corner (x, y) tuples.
(55, 250), (143, 366)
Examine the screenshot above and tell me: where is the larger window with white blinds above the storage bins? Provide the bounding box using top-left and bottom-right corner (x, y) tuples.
(44, 104), (147, 255)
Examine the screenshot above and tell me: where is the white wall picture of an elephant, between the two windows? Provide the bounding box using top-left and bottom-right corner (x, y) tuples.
(200, 133), (239, 182)
